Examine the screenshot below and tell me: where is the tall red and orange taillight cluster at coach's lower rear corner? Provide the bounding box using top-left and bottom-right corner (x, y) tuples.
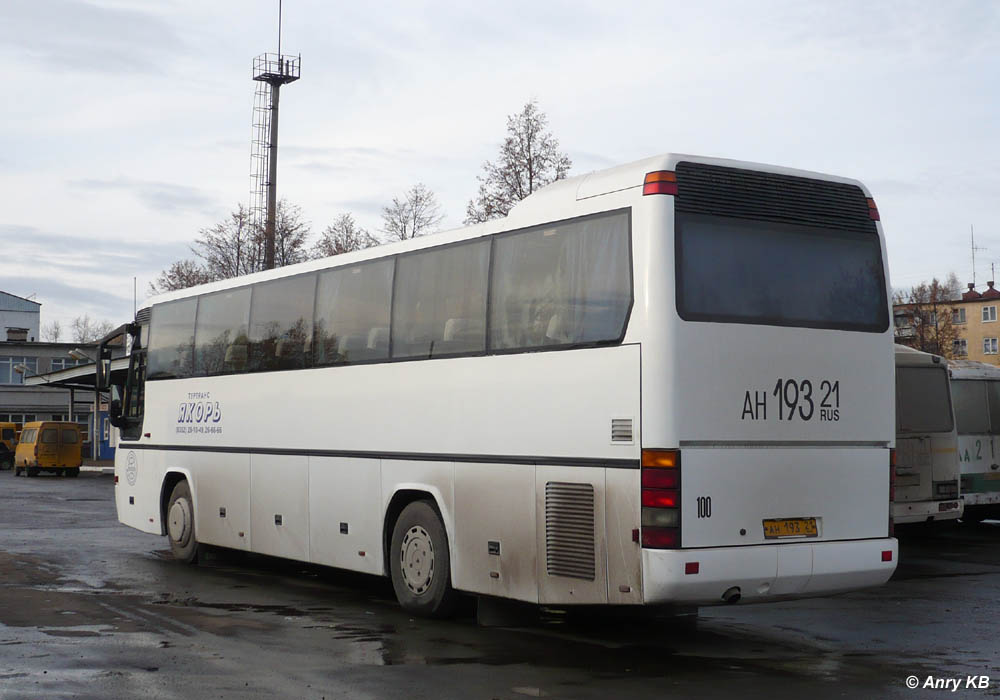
(641, 450), (681, 549)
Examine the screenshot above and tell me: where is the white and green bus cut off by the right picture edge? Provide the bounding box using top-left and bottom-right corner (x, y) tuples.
(949, 360), (1000, 522)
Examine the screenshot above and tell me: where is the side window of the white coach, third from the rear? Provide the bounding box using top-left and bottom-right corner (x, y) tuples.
(314, 260), (393, 366)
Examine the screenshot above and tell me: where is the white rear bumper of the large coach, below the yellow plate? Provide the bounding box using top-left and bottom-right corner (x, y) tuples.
(642, 537), (899, 605)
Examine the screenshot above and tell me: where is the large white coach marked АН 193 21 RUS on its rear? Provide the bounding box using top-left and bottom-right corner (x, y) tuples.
(101, 155), (896, 615)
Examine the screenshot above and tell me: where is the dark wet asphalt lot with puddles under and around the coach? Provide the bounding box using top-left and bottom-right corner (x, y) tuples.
(0, 472), (1000, 700)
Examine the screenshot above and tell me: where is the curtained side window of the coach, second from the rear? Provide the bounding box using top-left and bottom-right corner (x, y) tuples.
(392, 240), (490, 357)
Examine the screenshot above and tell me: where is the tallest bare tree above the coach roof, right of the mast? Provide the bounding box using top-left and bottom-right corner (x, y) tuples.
(465, 100), (573, 224)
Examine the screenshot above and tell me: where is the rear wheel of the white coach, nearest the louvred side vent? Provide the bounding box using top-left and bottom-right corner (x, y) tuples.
(389, 501), (456, 617)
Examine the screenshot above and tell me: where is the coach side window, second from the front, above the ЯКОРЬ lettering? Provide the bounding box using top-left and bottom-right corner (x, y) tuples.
(194, 287), (250, 377)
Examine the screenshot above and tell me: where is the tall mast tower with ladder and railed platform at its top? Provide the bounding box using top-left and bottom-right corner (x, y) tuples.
(249, 0), (302, 270)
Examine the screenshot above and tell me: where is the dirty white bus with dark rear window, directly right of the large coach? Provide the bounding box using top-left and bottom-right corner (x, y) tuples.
(892, 345), (962, 525)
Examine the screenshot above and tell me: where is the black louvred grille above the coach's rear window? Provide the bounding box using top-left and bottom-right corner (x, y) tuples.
(674, 161), (876, 234)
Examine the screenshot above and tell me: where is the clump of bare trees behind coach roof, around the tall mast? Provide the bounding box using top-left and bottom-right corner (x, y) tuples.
(149, 199), (309, 293)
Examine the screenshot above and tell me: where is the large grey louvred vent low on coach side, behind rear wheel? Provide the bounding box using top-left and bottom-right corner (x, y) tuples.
(545, 481), (595, 581)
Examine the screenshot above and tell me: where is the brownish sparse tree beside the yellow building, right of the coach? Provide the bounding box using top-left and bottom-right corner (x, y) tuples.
(892, 277), (958, 358)
